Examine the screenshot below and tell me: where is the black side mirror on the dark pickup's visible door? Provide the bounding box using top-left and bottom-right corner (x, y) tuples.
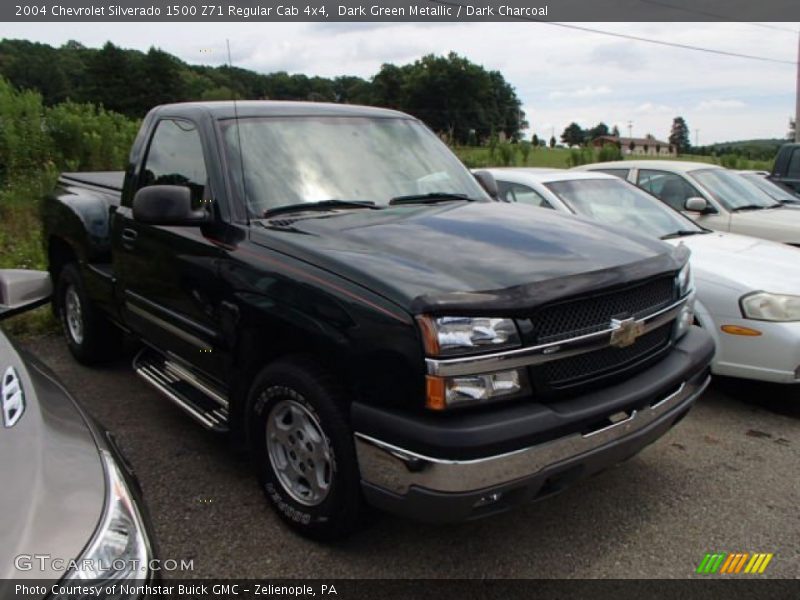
(133, 185), (209, 225)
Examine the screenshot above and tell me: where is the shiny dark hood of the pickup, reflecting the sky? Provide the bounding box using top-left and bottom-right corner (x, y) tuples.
(252, 202), (688, 313)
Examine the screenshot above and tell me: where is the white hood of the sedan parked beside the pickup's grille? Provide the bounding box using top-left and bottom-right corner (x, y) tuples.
(670, 232), (800, 296)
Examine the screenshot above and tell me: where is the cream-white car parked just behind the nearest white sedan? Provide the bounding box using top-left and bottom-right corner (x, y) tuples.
(575, 160), (800, 246)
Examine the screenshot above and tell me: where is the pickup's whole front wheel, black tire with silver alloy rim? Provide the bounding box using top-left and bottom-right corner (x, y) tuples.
(249, 361), (361, 540)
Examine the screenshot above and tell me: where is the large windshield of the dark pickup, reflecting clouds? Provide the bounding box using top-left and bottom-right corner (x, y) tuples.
(221, 116), (488, 217)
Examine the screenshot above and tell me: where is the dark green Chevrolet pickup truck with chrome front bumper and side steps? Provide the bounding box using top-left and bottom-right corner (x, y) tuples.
(44, 102), (713, 538)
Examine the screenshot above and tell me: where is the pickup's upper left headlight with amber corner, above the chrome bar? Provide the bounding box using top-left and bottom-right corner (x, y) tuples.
(417, 315), (521, 356)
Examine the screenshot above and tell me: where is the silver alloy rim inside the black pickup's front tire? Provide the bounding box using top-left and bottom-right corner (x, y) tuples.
(267, 400), (335, 506)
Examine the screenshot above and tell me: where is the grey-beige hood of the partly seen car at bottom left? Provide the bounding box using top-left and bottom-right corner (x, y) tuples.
(0, 334), (105, 580)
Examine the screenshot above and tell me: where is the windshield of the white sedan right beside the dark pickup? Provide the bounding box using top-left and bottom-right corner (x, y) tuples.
(545, 179), (705, 238)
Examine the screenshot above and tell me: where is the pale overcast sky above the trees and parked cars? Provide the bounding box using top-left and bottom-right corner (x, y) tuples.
(0, 22), (798, 145)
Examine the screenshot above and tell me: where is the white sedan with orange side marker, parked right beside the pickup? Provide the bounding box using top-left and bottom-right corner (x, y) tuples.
(490, 169), (800, 383)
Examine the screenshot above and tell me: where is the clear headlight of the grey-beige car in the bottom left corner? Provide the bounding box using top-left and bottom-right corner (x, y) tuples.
(64, 450), (150, 584)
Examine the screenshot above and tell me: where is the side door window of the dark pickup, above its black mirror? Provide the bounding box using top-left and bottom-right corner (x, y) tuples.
(140, 119), (208, 207)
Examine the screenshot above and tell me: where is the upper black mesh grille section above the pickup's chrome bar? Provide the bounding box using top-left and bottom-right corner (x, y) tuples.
(531, 275), (678, 344)
